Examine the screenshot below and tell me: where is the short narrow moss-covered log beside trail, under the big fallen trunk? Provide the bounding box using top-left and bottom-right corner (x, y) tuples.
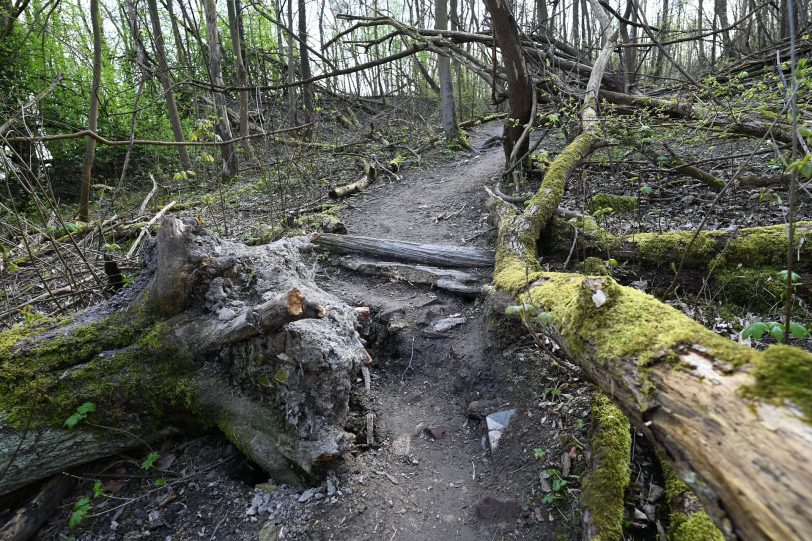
(581, 392), (632, 541)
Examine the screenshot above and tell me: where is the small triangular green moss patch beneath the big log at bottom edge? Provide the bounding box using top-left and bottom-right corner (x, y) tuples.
(660, 459), (725, 541)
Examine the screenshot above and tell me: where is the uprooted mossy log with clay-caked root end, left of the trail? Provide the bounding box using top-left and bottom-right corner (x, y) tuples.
(0, 218), (368, 495)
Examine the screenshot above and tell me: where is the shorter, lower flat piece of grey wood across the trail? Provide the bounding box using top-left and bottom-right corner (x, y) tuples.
(337, 257), (484, 297)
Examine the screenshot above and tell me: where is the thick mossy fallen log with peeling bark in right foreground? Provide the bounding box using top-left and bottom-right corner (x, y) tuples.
(494, 193), (812, 540)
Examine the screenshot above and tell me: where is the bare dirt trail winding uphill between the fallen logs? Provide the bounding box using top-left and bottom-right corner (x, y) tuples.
(307, 124), (589, 540)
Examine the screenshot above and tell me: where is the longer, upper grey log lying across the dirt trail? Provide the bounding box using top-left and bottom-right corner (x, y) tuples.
(311, 234), (494, 267)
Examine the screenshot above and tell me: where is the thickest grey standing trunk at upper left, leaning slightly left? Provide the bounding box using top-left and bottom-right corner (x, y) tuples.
(203, 0), (237, 178)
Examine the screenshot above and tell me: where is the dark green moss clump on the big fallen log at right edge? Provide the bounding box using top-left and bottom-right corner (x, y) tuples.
(742, 345), (812, 423)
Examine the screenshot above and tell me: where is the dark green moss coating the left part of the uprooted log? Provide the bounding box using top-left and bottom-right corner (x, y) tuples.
(0, 314), (197, 426)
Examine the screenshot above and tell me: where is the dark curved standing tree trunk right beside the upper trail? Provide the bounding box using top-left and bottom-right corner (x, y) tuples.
(485, 0), (533, 167)
